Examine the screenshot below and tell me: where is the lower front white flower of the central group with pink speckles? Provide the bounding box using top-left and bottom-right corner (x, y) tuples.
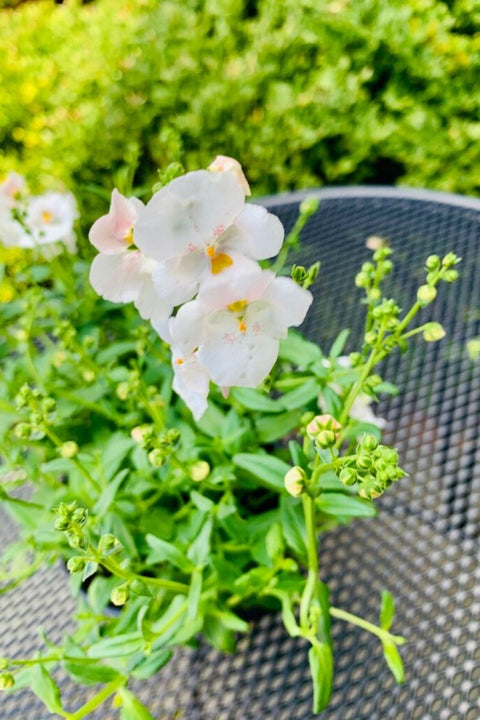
(170, 258), (312, 404)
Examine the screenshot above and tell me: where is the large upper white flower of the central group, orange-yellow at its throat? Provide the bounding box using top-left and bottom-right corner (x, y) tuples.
(135, 170), (284, 306)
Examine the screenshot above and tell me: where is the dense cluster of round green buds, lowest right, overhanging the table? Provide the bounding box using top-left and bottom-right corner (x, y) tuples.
(340, 435), (406, 500)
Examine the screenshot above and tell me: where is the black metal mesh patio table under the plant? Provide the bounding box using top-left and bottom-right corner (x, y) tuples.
(0, 187), (480, 720)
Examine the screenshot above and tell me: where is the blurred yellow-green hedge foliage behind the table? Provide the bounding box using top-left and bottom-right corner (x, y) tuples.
(0, 0), (480, 224)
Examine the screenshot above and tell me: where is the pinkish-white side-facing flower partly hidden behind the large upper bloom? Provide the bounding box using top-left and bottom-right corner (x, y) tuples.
(88, 190), (173, 337)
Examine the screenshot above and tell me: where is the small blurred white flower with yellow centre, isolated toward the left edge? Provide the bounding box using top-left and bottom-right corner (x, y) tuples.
(25, 192), (78, 252)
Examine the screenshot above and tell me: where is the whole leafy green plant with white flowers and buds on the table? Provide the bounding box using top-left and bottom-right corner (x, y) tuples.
(0, 156), (459, 720)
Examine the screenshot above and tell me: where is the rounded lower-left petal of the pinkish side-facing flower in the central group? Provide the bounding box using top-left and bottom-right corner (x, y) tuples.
(90, 251), (144, 302)
